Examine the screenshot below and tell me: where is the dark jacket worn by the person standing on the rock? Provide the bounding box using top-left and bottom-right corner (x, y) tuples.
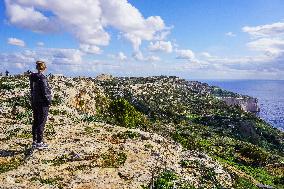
(30, 73), (52, 106)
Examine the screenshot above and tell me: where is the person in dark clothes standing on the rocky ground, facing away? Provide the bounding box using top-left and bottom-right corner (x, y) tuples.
(29, 61), (52, 149)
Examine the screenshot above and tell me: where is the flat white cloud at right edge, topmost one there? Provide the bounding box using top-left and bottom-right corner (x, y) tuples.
(242, 22), (284, 37)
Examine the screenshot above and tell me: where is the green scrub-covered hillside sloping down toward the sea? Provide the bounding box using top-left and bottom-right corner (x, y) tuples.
(99, 76), (284, 188)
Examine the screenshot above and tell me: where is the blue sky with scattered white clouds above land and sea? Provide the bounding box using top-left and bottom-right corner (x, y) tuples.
(0, 0), (284, 80)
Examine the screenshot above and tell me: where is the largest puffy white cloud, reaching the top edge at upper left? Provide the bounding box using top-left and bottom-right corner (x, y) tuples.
(5, 0), (169, 54)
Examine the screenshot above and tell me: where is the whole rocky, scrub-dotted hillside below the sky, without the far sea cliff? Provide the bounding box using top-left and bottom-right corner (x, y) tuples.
(0, 75), (284, 188)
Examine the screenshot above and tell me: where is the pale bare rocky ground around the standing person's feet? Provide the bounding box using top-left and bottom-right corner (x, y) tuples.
(0, 74), (232, 189)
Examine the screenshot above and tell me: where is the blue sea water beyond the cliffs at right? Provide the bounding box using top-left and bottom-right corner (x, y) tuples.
(201, 80), (284, 131)
